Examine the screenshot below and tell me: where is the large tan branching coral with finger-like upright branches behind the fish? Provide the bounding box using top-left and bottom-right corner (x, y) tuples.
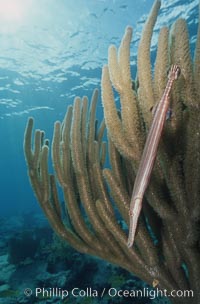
(24, 1), (200, 304)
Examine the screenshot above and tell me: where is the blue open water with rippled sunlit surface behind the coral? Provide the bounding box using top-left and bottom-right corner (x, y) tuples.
(0, 0), (198, 216)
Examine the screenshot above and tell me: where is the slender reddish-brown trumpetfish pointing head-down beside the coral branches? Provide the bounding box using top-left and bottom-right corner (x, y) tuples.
(127, 65), (181, 247)
